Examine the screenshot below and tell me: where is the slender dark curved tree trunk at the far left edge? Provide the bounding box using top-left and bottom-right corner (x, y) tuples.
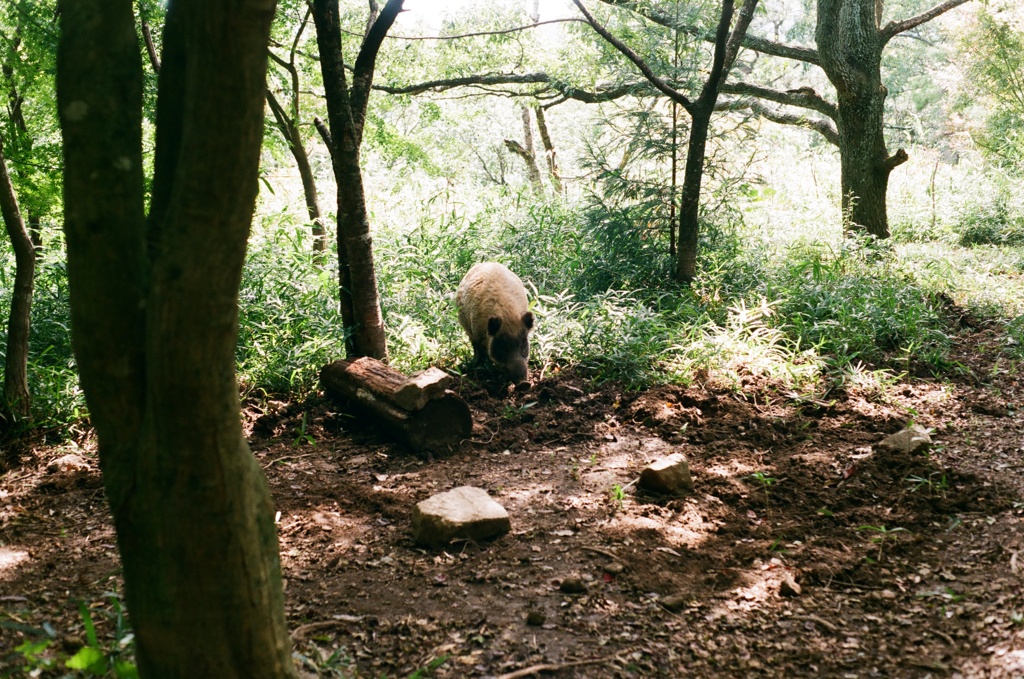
(0, 144), (36, 426)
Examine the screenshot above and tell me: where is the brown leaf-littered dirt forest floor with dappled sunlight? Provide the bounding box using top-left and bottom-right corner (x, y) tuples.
(0, 321), (1024, 678)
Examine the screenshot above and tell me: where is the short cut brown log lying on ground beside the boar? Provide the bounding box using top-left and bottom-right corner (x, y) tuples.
(319, 357), (473, 453)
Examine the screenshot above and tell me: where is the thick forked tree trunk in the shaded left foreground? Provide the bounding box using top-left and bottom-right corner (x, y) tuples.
(57, 0), (295, 678)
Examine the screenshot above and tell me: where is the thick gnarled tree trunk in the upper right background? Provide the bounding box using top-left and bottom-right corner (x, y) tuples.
(815, 0), (906, 239)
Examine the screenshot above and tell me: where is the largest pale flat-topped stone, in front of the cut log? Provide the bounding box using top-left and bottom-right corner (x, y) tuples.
(413, 485), (512, 547)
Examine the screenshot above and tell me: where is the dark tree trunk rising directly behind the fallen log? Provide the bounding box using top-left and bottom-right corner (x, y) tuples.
(313, 0), (385, 360)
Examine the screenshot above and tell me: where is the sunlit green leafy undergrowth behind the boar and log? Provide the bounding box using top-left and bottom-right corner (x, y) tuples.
(6, 155), (1024, 436)
